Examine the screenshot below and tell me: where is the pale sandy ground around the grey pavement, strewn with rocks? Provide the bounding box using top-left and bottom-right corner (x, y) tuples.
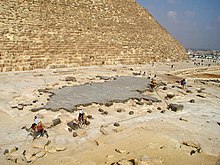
(0, 60), (220, 165)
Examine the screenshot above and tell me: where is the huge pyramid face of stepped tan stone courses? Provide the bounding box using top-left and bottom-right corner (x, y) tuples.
(0, 0), (186, 71)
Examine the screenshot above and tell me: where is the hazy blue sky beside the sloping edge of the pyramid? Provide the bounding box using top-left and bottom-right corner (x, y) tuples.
(136, 0), (220, 50)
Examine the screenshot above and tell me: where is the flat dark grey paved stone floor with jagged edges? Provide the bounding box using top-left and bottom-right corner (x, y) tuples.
(44, 76), (159, 111)
